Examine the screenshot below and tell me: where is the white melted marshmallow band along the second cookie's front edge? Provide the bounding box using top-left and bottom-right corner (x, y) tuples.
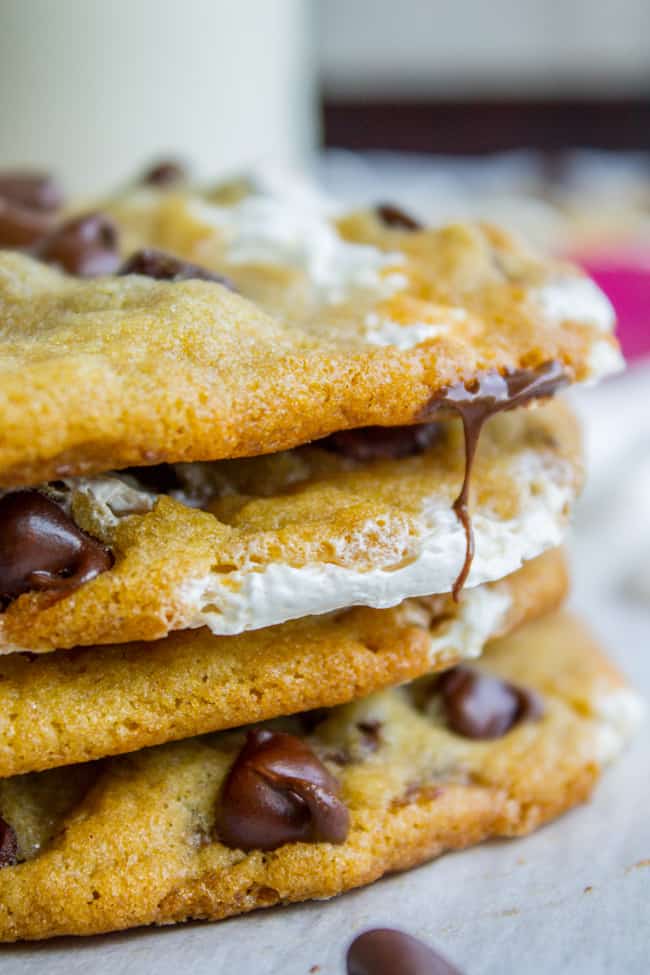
(177, 451), (575, 634)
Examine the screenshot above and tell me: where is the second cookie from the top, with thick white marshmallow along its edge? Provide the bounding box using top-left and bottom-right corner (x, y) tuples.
(0, 401), (582, 652)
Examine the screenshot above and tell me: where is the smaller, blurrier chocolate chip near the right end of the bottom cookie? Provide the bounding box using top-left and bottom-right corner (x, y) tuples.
(435, 665), (544, 739)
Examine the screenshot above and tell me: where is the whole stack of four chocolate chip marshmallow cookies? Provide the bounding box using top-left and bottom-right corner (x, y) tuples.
(0, 164), (639, 941)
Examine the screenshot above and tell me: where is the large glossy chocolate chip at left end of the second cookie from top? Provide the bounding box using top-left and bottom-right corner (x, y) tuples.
(0, 491), (113, 604)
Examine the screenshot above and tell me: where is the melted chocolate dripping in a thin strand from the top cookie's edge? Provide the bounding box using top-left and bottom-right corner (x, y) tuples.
(422, 361), (569, 601)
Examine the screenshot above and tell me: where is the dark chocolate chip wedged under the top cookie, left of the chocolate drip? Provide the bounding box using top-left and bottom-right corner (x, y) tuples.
(316, 423), (441, 463)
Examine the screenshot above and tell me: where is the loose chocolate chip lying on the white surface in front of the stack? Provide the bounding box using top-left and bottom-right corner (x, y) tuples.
(347, 928), (461, 975)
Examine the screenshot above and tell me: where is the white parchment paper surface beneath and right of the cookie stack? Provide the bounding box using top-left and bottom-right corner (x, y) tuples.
(0, 368), (650, 975)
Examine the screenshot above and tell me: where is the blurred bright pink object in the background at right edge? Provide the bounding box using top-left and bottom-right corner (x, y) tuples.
(573, 250), (650, 360)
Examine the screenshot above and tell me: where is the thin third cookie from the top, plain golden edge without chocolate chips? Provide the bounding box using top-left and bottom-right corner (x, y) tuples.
(0, 550), (568, 777)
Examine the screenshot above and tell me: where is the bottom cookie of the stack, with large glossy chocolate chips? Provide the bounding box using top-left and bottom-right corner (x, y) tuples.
(0, 614), (640, 941)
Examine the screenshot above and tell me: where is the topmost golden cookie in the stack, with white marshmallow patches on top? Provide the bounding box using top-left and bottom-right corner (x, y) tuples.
(0, 178), (621, 486)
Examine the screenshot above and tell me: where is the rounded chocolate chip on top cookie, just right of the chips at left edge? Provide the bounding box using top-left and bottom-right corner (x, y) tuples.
(32, 213), (120, 278)
